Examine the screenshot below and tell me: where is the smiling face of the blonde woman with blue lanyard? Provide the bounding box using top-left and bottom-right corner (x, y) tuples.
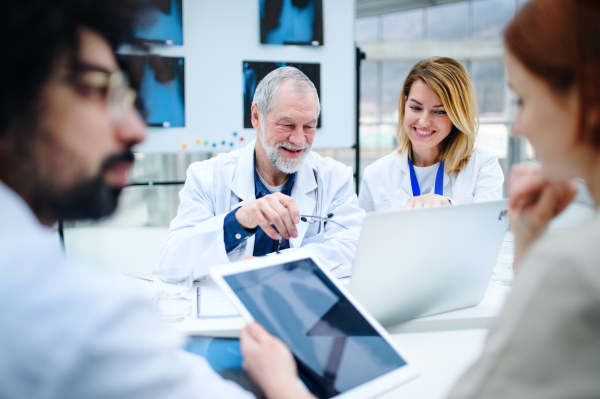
(404, 79), (452, 166)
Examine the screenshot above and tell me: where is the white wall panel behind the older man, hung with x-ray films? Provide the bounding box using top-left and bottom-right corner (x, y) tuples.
(130, 0), (355, 153)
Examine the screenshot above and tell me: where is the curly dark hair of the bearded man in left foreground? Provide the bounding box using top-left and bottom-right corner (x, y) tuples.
(0, 0), (148, 139)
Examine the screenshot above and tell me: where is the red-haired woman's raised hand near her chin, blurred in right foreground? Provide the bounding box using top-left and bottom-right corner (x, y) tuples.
(508, 164), (577, 265)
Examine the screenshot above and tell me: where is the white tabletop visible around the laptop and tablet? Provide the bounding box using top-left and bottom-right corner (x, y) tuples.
(131, 281), (509, 399)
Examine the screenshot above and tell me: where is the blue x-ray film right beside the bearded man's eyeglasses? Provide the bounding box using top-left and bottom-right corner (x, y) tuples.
(119, 55), (185, 127)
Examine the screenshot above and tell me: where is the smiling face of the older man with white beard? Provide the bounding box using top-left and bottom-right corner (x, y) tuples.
(252, 82), (318, 178)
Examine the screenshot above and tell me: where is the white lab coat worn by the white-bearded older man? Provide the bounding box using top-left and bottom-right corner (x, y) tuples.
(159, 140), (364, 278)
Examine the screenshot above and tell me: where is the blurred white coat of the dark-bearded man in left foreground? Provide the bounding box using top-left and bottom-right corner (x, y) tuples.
(0, 182), (254, 399)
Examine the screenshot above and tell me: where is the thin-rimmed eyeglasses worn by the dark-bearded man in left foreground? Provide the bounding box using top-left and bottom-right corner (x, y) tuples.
(60, 70), (136, 123)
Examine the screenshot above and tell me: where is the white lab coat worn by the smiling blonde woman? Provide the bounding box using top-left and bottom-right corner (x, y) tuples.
(359, 149), (504, 212)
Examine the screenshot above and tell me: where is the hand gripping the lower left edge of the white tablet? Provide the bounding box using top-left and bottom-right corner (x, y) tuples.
(240, 321), (314, 399)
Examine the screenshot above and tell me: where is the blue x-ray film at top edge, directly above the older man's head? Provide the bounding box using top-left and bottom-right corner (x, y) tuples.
(260, 0), (323, 46)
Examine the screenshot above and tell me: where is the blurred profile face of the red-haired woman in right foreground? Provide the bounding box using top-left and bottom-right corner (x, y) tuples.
(506, 52), (588, 180)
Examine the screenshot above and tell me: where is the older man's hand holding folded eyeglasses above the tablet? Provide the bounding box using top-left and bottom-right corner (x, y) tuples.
(235, 193), (300, 240)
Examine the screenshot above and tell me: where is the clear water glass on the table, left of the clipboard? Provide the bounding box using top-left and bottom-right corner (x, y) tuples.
(152, 266), (194, 322)
